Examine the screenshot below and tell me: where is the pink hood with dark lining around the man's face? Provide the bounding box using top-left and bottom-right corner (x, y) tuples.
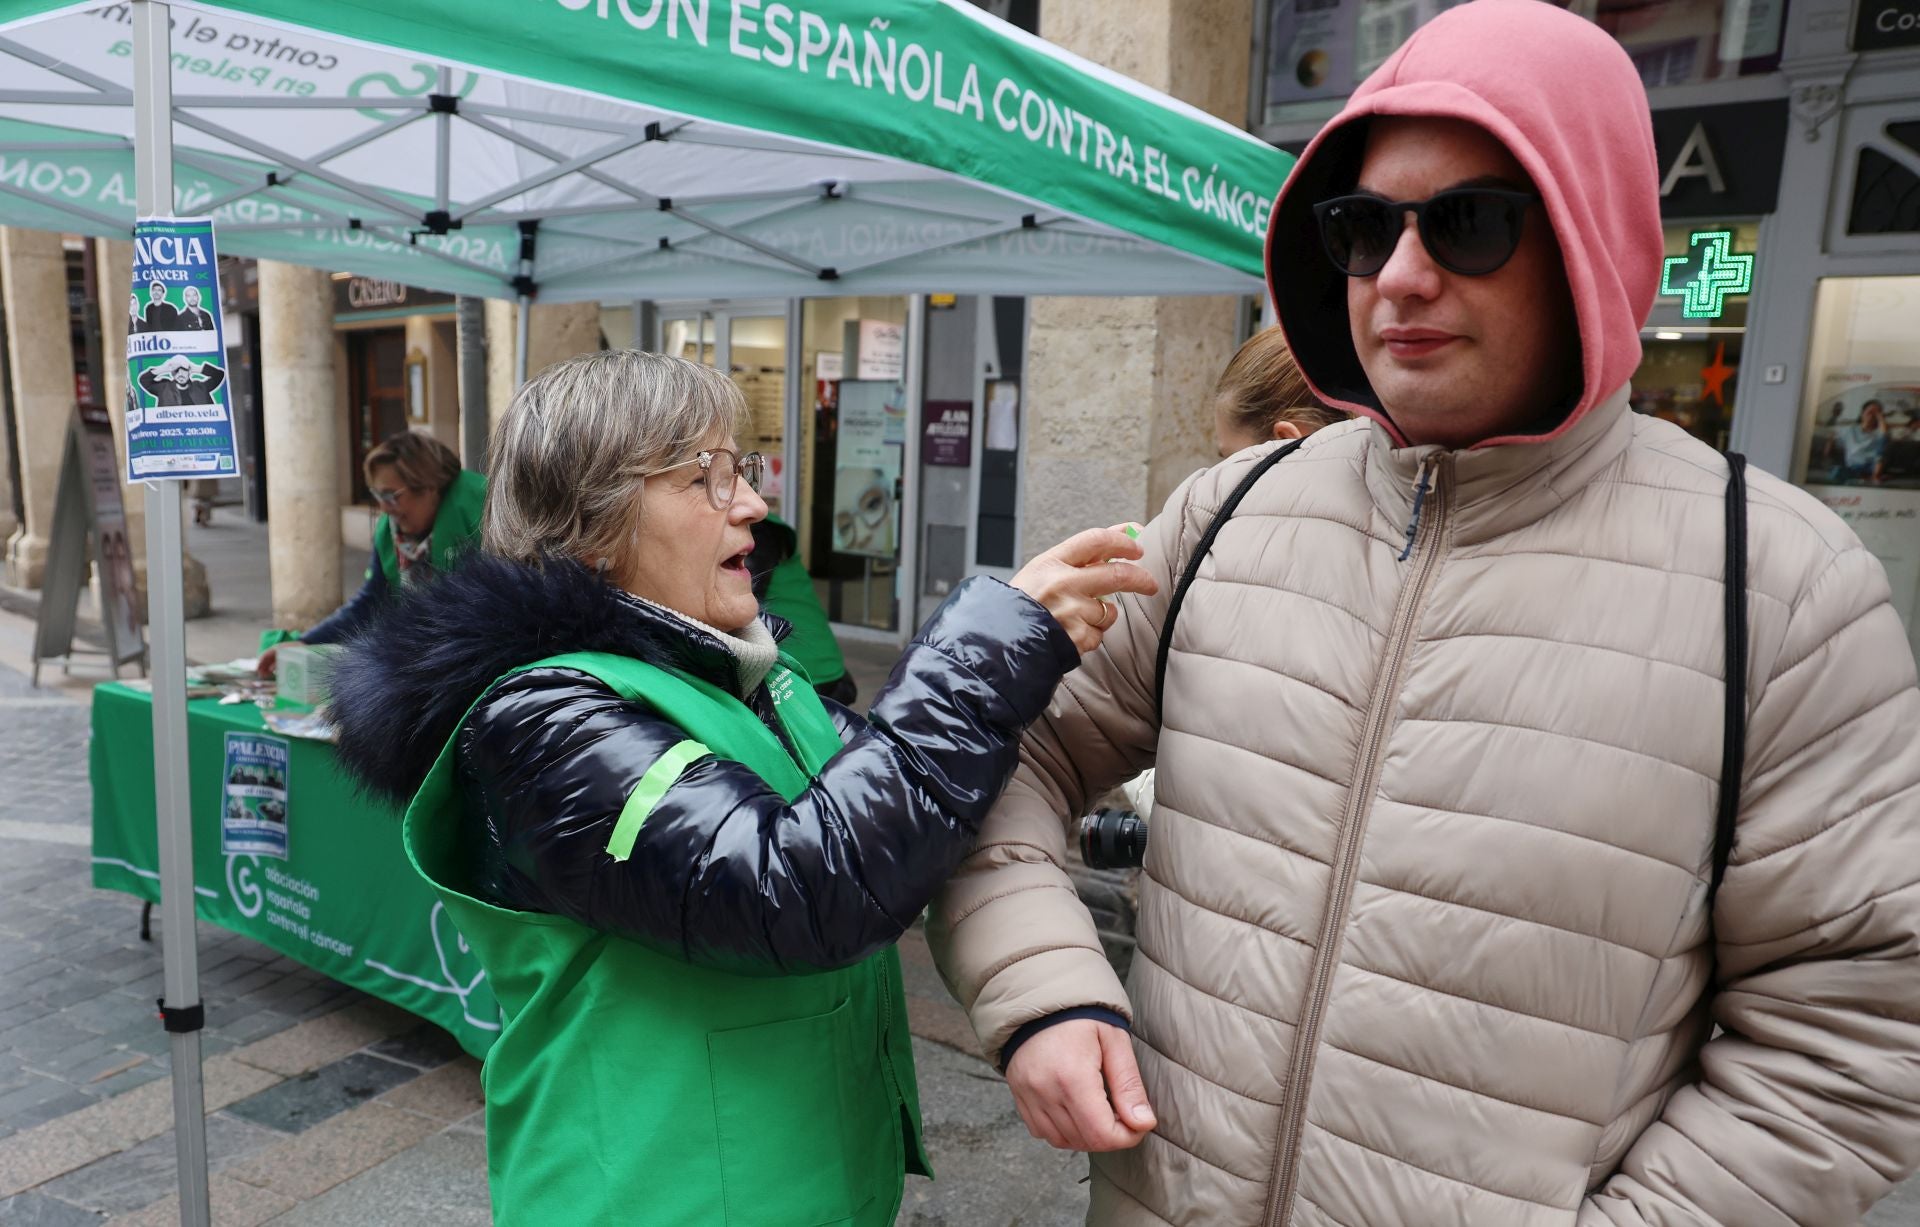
(1267, 0), (1663, 447)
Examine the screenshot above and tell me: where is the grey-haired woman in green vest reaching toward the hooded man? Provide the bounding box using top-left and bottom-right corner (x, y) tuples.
(332, 349), (1154, 1227)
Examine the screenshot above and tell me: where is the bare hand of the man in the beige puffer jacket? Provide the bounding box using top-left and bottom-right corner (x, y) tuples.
(1006, 1018), (1156, 1150)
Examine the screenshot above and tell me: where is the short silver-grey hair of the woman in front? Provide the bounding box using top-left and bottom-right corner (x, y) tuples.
(482, 349), (747, 574)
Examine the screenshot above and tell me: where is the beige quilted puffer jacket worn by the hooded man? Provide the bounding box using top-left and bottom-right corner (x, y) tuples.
(933, 388), (1920, 1227)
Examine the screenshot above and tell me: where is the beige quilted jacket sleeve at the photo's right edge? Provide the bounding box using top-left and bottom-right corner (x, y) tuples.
(1578, 543), (1920, 1227)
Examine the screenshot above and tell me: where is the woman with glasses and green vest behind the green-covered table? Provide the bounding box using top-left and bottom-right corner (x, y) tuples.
(259, 430), (486, 678)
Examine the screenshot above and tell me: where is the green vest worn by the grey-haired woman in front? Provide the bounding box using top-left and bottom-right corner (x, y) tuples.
(403, 653), (931, 1227)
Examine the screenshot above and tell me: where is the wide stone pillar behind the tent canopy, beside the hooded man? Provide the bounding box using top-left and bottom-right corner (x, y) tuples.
(1021, 0), (1254, 559)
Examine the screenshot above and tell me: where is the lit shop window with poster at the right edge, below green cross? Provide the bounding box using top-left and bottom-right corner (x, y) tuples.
(1793, 277), (1920, 653)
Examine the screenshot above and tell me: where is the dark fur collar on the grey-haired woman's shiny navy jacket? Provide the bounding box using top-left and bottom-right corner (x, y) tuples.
(330, 553), (787, 803)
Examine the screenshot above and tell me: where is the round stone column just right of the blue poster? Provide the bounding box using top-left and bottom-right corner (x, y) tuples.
(259, 259), (340, 630)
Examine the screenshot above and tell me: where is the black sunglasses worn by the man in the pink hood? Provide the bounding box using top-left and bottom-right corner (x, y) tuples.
(1313, 188), (1540, 277)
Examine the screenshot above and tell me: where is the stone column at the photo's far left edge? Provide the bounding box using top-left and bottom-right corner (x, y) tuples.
(0, 227), (73, 588)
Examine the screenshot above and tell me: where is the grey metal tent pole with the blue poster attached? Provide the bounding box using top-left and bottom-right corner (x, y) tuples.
(132, 0), (211, 1227)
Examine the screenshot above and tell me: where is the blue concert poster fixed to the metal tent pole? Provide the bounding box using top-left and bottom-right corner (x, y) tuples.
(127, 217), (236, 482)
